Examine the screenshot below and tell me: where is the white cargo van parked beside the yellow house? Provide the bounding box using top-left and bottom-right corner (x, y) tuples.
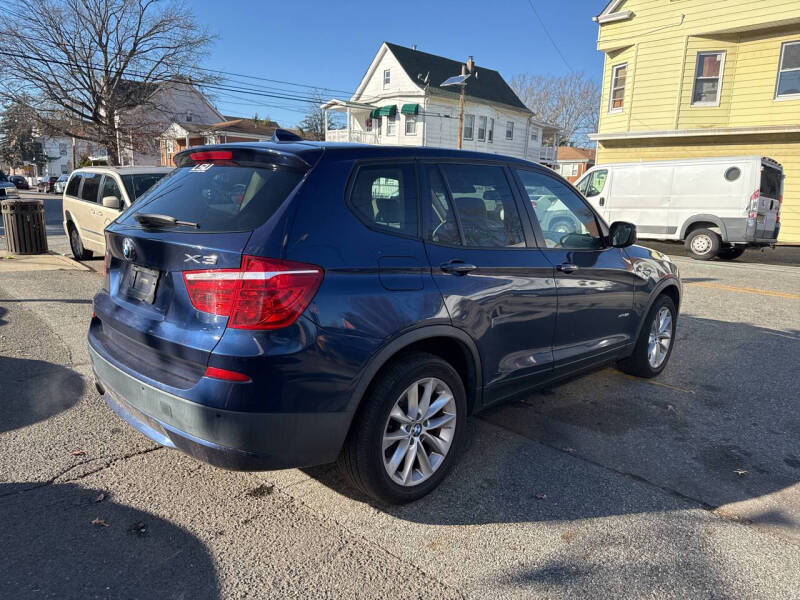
(575, 156), (783, 260)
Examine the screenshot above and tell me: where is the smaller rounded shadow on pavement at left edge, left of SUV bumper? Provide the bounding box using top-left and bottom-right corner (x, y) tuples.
(0, 358), (84, 433)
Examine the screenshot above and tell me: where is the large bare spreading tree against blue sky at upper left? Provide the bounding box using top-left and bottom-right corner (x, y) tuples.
(0, 0), (213, 164)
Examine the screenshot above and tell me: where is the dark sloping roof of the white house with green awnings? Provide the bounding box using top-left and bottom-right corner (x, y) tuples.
(384, 42), (531, 113)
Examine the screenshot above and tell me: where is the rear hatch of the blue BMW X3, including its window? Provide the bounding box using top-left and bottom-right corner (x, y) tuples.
(90, 146), (316, 389)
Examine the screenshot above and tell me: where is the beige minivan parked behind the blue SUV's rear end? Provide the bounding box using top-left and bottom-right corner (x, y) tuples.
(62, 167), (172, 260)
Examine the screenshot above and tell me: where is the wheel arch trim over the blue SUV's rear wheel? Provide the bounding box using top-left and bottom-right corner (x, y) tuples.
(349, 325), (483, 414)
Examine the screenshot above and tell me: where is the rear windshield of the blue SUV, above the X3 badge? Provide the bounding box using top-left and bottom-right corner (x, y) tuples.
(119, 164), (303, 232)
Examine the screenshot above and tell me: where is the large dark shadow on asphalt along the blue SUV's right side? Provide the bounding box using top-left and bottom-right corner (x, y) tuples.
(306, 315), (800, 525)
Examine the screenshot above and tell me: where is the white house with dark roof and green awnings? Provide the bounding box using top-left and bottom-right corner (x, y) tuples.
(322, 42), (558, 167)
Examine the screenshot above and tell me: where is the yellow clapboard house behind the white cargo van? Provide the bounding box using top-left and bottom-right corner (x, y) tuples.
(589, 0), (800, 243)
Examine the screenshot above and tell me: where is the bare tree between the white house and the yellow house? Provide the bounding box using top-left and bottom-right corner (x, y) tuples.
(511, 71), (600, 145)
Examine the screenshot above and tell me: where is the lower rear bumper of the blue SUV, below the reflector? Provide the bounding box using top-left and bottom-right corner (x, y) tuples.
(89, 344), (352, 471)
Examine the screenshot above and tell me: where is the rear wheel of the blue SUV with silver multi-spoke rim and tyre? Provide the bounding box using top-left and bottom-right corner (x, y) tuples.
(338, 353), (467, 504)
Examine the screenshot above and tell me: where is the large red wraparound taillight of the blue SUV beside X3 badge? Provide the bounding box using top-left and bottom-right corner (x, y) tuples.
(183, 256), (323, 329)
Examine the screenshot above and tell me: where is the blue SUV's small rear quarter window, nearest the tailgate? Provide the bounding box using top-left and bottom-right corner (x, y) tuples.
(350, 163), (417, 236)
